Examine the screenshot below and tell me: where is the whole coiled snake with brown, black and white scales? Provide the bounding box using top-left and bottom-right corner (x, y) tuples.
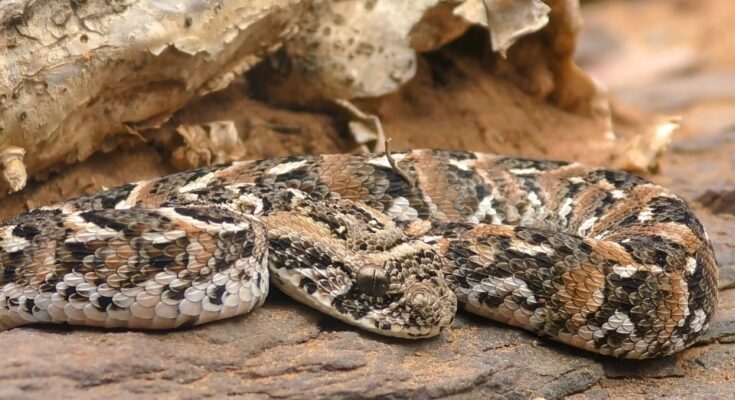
(0, 149), (718, 359)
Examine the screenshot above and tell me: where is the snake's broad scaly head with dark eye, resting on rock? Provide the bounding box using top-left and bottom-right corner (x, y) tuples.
(264, 201), (457, 338)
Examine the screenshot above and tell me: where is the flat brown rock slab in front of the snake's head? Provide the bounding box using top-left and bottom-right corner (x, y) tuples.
(0, 291), (603, 399)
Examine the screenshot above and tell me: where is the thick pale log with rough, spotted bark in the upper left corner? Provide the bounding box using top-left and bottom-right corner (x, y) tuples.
(0, 0), (304, 190)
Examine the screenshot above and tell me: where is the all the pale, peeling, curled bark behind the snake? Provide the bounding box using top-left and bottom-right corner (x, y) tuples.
(0, 0), (670, 195)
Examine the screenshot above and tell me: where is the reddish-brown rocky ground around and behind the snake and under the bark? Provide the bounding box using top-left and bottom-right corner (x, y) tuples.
(0, 0), (735, 399)
